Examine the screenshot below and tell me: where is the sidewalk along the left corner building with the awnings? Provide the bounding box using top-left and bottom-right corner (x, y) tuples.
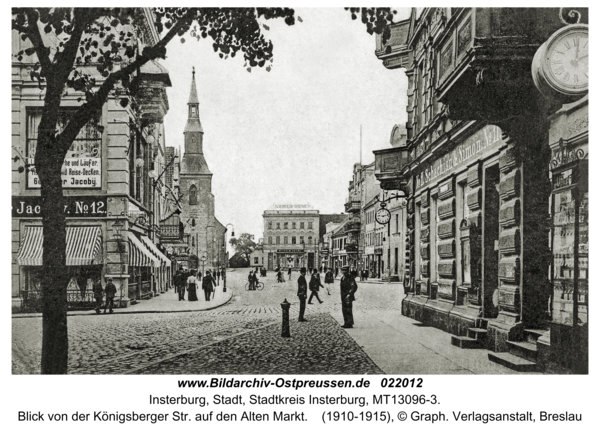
(12, 281), (233, 318)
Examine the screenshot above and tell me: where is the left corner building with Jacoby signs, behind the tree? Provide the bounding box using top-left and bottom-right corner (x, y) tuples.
(12, 8), (171, 310)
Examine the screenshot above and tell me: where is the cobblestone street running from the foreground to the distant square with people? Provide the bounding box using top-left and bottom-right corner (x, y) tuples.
(12, 270), (402, 374)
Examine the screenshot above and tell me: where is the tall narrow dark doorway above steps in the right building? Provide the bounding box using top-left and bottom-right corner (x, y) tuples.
(482, 165), (500, 318)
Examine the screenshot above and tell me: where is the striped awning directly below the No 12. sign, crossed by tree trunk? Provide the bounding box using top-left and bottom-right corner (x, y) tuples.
(17, 226), (102, 266)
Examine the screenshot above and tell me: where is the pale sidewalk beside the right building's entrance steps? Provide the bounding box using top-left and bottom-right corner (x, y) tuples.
(332, 311), (537, 375)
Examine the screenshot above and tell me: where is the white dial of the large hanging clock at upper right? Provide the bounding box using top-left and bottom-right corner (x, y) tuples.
(545, 26), (589, 92)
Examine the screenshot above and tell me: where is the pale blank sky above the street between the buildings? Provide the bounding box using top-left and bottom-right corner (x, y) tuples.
(162, 7), (409, 240)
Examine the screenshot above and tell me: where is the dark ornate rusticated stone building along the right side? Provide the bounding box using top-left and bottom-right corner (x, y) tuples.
(375, 8), (587, 371)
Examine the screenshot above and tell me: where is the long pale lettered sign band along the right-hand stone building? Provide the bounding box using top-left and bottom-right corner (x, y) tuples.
(416, 125), (502, 189)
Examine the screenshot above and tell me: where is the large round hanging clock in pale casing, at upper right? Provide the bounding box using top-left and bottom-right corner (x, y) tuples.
(531, 24), (589, 103)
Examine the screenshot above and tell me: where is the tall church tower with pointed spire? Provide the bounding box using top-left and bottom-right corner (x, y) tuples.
(179, 68), (218, 270)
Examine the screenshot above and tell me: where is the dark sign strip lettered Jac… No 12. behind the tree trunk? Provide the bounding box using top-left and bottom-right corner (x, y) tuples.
(12, 196), (106, 217)
